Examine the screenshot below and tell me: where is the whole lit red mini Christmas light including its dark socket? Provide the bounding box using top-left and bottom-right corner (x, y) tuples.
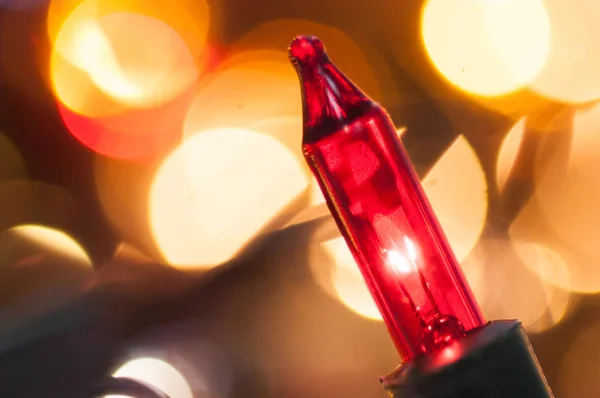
(289, 36), (552, 398)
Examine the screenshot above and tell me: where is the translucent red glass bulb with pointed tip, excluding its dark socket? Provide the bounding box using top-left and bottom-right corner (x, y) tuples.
(290, 36), (485, 360)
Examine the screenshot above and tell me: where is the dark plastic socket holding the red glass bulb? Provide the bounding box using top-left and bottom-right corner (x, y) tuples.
(382, 321), (554, 398)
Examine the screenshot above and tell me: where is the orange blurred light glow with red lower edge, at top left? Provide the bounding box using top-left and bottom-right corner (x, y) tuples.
(49, 0), (208, 159)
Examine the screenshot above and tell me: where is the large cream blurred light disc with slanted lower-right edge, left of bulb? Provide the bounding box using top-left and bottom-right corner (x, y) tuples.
(150, 128), (308, 267)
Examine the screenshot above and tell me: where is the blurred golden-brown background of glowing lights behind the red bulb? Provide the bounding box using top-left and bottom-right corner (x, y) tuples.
(0, 0), (600, 398)
